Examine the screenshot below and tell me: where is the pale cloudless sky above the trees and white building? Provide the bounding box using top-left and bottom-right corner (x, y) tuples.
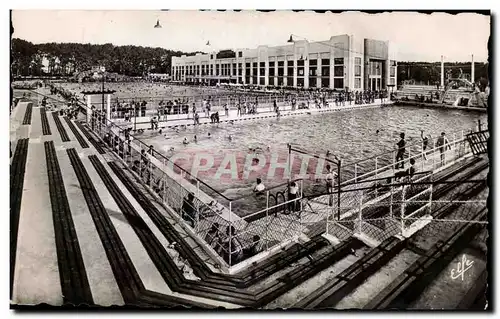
(12, 10), (490, 62)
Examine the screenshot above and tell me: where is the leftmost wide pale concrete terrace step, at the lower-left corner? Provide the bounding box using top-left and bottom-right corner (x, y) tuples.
(12, 143), (63, 305)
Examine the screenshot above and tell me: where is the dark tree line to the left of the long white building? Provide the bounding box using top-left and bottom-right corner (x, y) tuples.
(11, 38), (196, 76)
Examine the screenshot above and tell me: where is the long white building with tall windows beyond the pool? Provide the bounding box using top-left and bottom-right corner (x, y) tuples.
(172, 35), (397, 91)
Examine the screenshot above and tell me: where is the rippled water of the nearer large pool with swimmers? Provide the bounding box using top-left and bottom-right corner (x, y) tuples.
(138, 106), (487, 215)
